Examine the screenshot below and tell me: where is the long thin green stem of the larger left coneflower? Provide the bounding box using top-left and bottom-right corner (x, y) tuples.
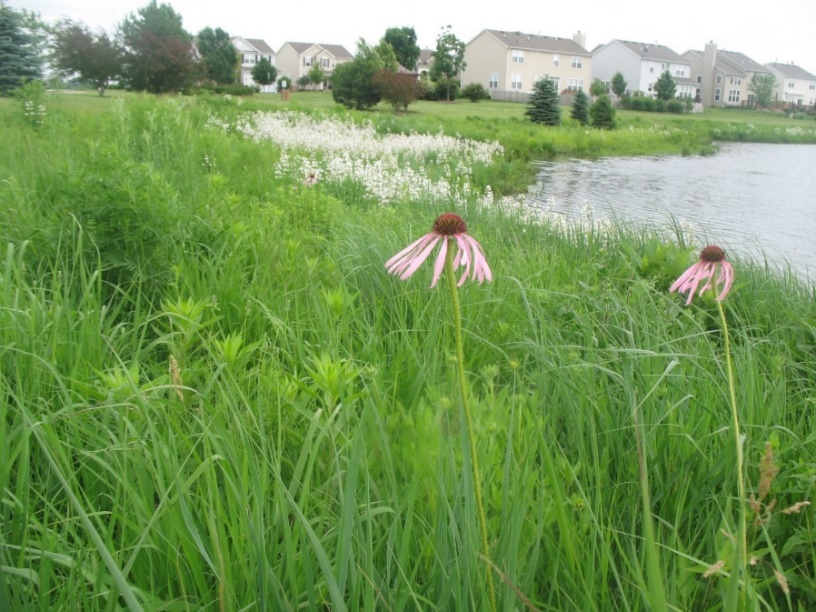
(445, 238), (496, 612)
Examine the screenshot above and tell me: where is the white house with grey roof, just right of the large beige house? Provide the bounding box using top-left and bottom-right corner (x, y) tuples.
(592, 39), (694, 98)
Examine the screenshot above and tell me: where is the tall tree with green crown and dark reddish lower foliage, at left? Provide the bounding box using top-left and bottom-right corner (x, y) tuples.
(119, 0), (199, 93)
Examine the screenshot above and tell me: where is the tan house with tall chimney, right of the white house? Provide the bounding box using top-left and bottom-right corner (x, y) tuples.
(683, 41), (771, 106)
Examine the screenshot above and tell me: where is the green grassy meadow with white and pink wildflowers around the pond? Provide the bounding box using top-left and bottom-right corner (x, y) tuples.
(0, 94), (816, 611)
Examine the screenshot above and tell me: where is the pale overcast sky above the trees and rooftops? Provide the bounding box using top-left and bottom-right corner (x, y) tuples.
(8, 0), (816, 74)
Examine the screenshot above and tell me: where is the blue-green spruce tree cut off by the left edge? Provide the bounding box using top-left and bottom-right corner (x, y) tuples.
(0, 4), (41, 94)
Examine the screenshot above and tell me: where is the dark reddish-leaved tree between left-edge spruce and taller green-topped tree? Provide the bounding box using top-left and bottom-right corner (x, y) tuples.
(51, 19), (122, 96)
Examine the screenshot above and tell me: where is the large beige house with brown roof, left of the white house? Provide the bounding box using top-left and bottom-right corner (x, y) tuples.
(460, 30), (592, 101)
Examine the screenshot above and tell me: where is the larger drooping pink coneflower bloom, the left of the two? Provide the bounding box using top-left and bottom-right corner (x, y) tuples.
(385, 213), (493, 287)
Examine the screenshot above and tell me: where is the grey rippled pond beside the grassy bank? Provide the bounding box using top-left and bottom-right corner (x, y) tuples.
(527, 144), (816, 282)
